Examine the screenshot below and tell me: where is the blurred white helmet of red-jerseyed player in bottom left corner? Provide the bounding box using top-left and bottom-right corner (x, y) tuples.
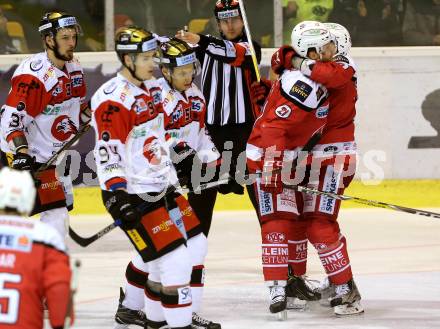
(0, 167), (37, 215)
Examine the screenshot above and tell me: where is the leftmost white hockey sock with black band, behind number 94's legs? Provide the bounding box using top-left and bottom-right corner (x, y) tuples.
(122, 257), (148, 310)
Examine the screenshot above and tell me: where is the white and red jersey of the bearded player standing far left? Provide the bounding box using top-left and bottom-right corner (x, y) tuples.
(1, 52), (86, 163)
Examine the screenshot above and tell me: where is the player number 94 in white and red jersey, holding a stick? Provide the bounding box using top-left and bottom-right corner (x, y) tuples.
(91, 27), (205, 329)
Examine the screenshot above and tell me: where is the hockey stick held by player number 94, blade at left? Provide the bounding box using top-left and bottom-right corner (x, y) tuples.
(69, 178), (229, 247)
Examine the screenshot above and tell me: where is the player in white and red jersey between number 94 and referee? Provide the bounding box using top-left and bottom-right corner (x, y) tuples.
(155, 39), (221, 329)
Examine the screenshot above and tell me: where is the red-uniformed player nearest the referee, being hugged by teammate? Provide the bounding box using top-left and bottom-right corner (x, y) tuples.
(246, 18), (335, 313)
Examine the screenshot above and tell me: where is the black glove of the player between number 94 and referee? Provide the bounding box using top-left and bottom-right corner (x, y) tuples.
(171, 142), (198, 189)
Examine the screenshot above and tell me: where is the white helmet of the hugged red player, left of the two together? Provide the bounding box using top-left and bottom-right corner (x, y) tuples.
(291, 21), (336, 57)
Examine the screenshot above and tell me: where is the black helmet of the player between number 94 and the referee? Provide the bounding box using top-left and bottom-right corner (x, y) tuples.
(154, 38), (197, 67)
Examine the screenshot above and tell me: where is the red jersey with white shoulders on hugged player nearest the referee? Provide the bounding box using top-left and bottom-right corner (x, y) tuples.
(246, 71), (329, 170)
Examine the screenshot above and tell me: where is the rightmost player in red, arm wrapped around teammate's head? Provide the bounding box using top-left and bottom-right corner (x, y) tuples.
(272, 23), (363, 315)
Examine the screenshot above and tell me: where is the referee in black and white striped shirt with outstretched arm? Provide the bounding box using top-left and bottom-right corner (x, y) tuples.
(176, 0), (261, 232)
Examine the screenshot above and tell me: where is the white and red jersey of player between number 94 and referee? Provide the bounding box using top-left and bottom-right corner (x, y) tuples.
(158, 78), (220, 163)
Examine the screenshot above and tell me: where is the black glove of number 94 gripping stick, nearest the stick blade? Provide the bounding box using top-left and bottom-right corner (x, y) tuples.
(102, 190), (141, 231)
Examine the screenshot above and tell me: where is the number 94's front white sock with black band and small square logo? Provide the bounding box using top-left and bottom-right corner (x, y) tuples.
(160, 286), (192, 328)
